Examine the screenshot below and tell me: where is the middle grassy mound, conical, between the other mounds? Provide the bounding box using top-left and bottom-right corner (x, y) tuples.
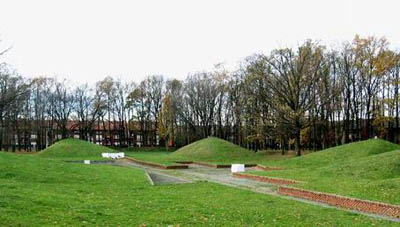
(170, 137), (257, 163)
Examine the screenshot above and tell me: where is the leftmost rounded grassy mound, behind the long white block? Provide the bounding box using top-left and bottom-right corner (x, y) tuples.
(38, 139), (116, 160)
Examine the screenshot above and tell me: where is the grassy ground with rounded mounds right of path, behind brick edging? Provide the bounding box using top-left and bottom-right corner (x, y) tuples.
(251, 139), (400, 205)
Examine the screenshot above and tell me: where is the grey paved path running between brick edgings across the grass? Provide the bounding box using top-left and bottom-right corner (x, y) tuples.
(114, 159), (400, 222)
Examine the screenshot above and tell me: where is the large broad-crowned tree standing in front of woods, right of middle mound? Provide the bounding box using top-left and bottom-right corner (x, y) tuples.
(265, 41), (324, 156)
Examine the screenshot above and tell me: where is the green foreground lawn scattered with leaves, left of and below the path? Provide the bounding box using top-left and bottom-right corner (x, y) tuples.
(0, 152), (397, 226)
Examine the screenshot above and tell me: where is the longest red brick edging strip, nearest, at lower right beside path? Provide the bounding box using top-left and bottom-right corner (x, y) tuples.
(278, 186), (400, 218)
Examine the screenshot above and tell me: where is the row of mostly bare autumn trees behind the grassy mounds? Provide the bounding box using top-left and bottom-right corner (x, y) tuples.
(0, 36), (400, 155)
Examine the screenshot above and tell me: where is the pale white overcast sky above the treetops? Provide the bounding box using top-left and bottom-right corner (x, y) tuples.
(0, 0), (400, 83)
